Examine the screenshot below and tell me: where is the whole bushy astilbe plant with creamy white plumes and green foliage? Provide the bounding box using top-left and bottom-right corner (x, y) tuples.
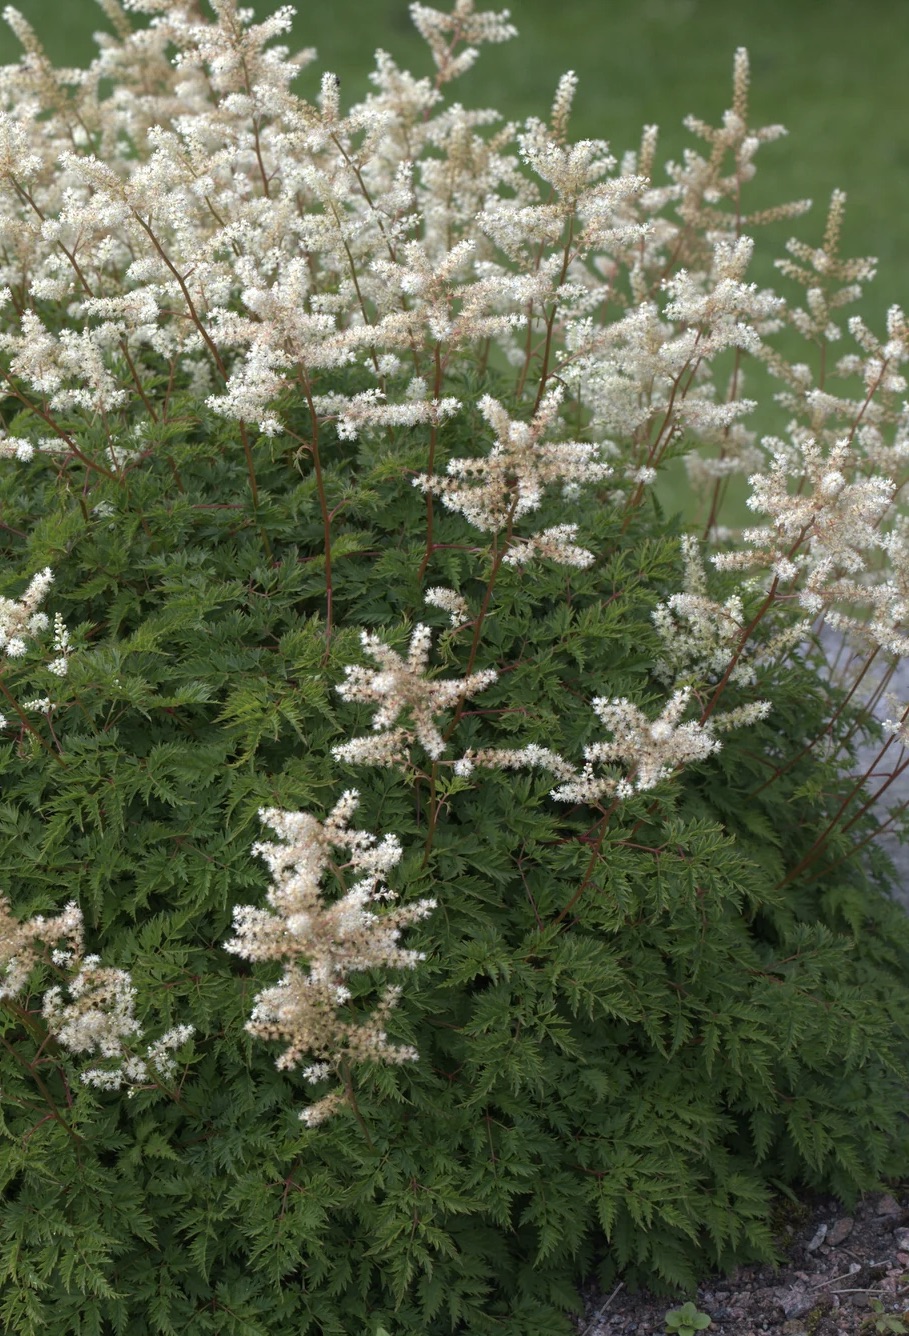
(0, 0), (909, 1336)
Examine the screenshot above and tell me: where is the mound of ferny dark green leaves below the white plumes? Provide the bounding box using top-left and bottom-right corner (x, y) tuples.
(0, 375), (909, 1336)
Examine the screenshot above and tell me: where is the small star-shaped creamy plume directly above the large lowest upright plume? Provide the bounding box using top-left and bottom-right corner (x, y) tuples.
(332, 623), (499, 766)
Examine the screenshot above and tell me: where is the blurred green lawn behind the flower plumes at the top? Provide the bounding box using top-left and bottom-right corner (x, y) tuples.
(0, 0), (909, 523)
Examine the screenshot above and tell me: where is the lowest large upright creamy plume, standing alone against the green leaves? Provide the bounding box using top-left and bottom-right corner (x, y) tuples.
(225, 788), (436, 1126)
